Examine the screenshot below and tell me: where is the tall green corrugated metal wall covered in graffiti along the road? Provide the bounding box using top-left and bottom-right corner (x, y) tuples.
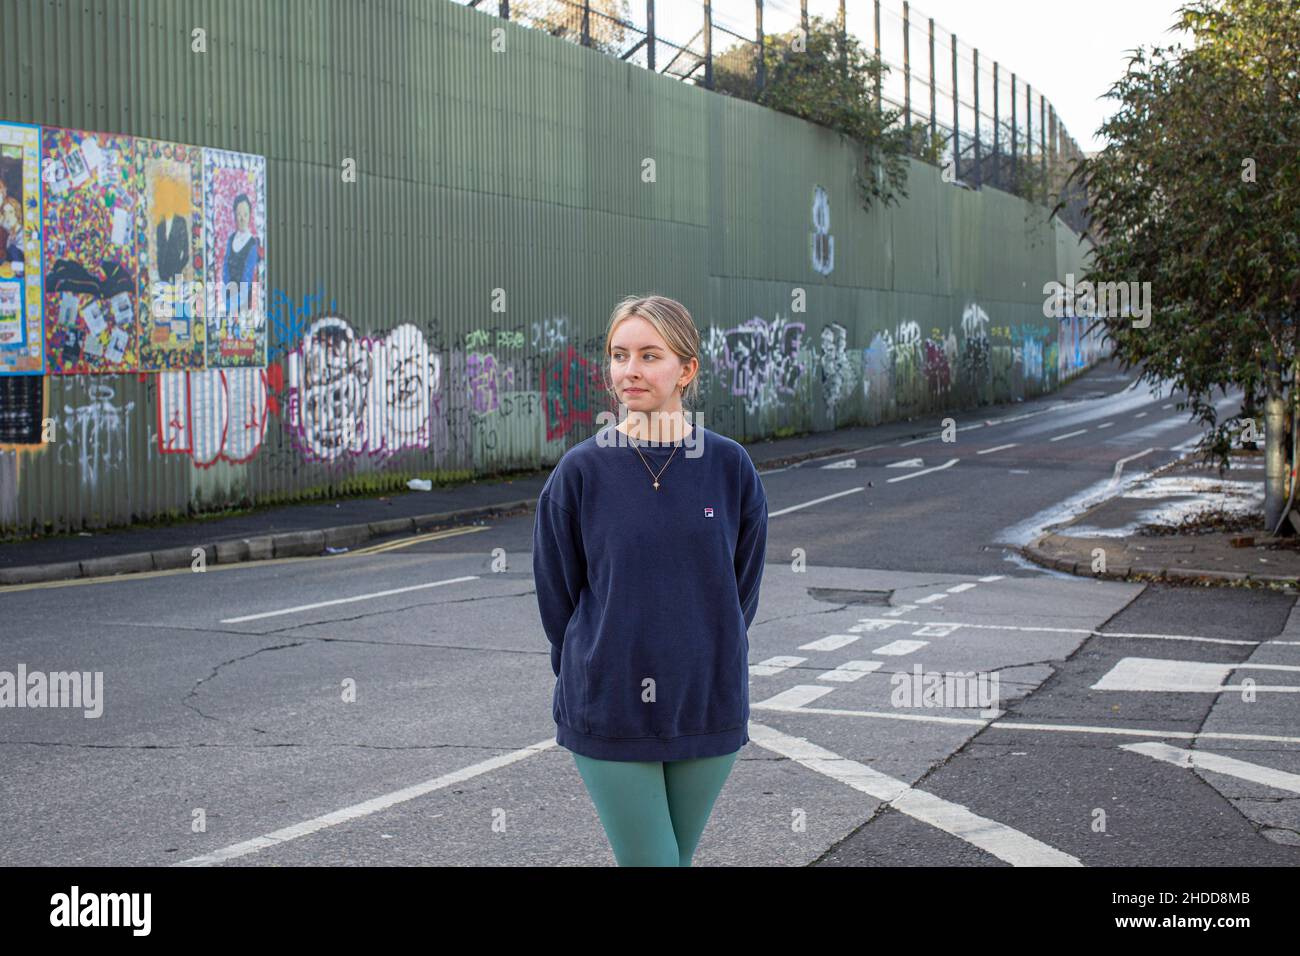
(0, 0), (1091, 532)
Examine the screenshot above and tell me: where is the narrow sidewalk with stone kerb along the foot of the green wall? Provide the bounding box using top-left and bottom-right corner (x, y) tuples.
(0, 377), (1097, 587)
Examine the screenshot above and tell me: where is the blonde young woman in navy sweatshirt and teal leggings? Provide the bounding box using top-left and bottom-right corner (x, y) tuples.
(533, 295), (767, 866)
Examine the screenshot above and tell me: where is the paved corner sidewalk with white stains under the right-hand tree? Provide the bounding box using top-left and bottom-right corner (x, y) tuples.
(1022, 453), (1300, 589)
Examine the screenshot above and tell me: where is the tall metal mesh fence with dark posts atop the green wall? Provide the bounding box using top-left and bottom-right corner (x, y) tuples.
(455, 0), (1087, 233)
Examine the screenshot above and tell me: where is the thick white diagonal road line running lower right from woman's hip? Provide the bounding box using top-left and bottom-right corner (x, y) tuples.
(749, 722), (1083, 866)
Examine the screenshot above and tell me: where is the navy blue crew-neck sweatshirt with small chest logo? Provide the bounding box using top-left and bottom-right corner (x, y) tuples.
(533, 424), (767, 761)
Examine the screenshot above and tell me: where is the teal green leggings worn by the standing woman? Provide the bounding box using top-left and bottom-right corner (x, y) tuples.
(573, 750), (740, 866)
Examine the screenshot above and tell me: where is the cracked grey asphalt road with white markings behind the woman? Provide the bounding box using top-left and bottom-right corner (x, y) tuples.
(0, 372), (1300, 866)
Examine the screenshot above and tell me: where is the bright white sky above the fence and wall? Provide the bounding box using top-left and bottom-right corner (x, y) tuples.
(655, 0), (1186, 152)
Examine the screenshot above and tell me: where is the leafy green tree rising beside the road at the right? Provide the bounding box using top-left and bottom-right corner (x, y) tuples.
(1071, 0), (1300, 529)
